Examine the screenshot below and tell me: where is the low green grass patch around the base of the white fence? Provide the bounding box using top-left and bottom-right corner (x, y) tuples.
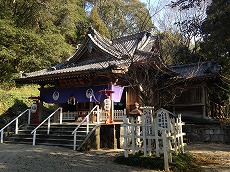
(115, 153), (204, 172)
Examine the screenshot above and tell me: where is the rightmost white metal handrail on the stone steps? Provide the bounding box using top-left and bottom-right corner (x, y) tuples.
(72, 105), (100, 150)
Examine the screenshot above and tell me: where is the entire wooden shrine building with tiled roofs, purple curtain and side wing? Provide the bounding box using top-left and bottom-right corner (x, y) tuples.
(11, 27), (223, 149)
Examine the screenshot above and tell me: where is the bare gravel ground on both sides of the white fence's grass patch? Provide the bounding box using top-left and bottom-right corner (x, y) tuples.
(0, 144), (230, 172)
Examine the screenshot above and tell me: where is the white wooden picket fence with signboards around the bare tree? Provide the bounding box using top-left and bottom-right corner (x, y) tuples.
(123, 107), (185, 171)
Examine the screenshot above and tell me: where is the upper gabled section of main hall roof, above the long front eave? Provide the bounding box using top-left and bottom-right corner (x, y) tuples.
(59, 28), (157, 67)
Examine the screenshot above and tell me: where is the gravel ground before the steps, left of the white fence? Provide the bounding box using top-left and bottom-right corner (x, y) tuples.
(0, 144), (158, 172)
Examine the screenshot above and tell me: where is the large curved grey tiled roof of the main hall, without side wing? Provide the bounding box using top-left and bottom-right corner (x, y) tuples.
(17, 28), (161, 82)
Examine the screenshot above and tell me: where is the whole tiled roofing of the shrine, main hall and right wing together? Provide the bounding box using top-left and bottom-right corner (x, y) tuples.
(16, 25), (220, 82)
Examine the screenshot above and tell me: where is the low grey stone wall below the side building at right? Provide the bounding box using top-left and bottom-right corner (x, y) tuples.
(183, 124), (230, 144)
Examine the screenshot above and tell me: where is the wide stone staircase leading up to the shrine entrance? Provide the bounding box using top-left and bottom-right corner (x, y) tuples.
(4, 123), (96, 149)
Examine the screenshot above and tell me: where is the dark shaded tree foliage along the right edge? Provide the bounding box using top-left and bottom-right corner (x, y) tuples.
(201, 0), (230, 107)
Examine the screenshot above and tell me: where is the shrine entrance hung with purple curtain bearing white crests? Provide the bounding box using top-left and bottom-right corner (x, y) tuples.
(40, 85), (126, 123)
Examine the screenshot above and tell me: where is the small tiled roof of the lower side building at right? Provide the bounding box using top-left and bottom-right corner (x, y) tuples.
(169, 61), (221, 78)
